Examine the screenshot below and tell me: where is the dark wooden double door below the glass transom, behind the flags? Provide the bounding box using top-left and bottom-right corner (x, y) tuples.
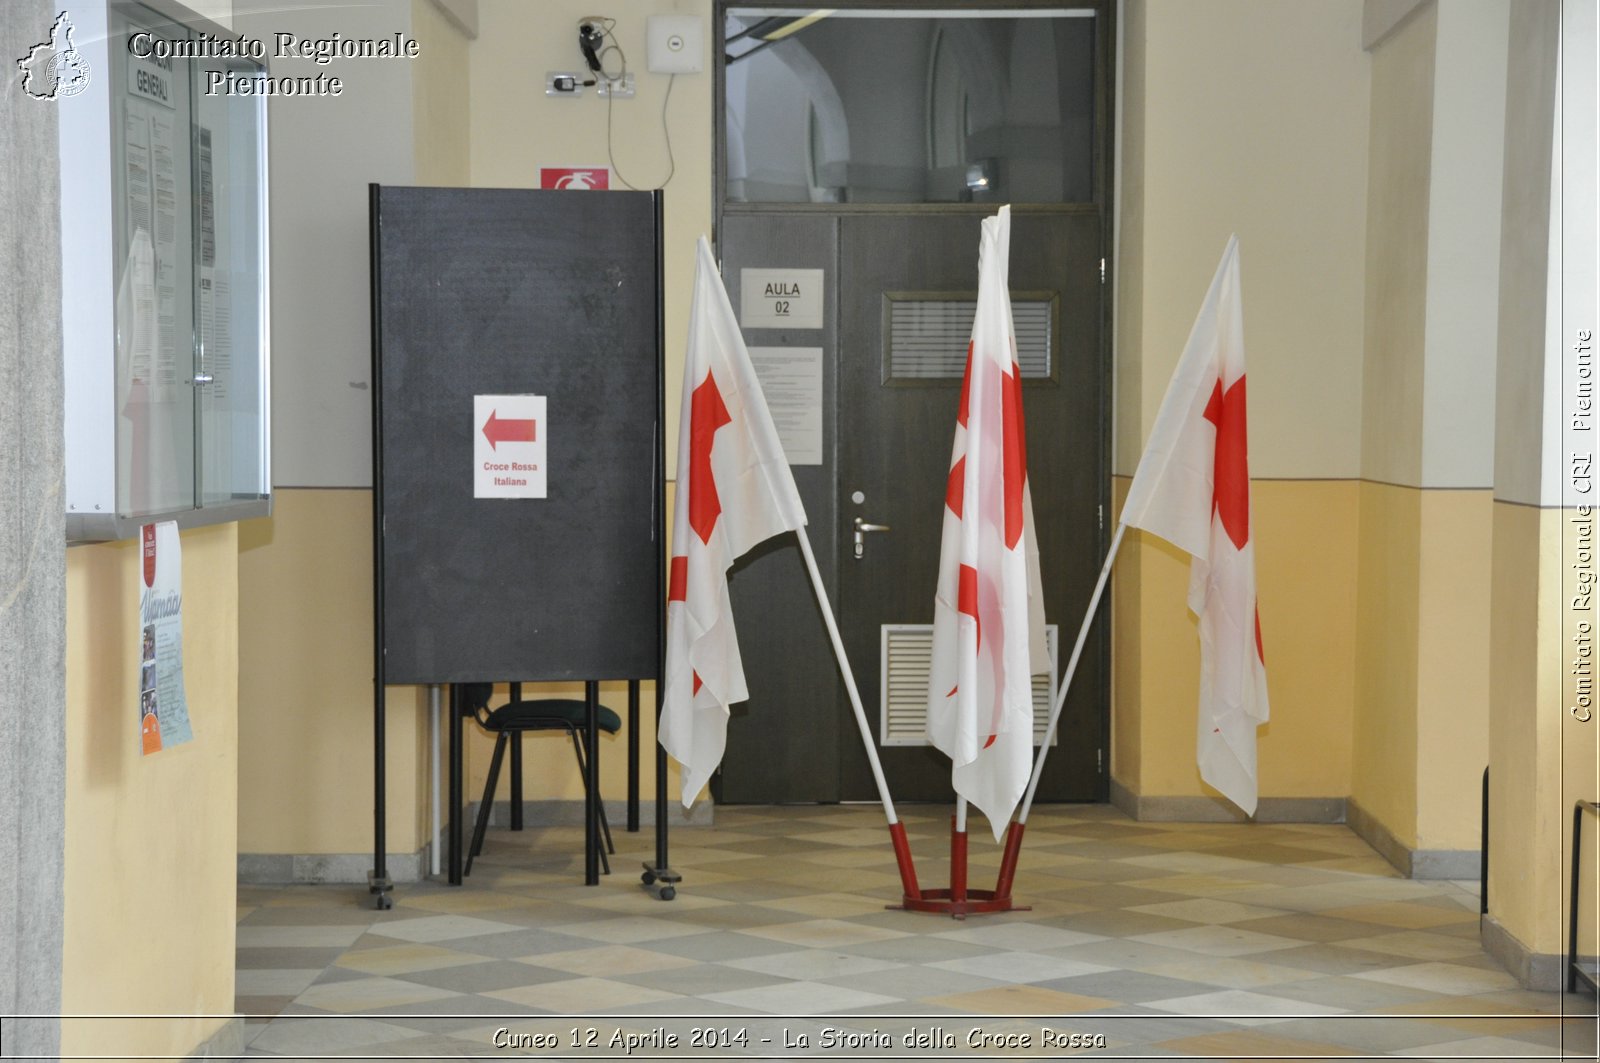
(717, 208), (1109, 802)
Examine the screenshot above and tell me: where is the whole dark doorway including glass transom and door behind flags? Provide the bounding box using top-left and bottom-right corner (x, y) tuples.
(714, 3), (1112, 804)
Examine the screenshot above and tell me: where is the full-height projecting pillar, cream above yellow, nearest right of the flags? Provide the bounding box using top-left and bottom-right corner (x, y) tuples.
(1350, 3), (1507, 850)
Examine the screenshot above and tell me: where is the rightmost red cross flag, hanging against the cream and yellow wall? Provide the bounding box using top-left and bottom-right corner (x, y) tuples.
(1122, 237), (1267, 815)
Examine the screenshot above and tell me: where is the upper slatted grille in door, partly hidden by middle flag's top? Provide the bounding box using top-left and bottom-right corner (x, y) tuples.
(886, 298), (1054, 381)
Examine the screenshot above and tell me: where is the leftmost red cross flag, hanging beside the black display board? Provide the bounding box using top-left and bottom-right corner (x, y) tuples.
(661, 237), (805, 808)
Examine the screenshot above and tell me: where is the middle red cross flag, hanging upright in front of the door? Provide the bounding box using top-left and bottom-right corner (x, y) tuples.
(928, 207), (1050, 840)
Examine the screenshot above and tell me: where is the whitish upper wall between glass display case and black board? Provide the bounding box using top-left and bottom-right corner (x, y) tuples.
(234, 0), (413, 487)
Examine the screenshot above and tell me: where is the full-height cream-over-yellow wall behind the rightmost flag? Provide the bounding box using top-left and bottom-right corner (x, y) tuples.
(1112, 0), (1368, 797)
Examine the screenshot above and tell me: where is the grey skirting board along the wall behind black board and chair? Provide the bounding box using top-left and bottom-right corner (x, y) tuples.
(238, 800), (714, 885)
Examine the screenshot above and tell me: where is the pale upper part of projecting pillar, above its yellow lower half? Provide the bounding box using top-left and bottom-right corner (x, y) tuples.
(1362, 0), (1510, 488)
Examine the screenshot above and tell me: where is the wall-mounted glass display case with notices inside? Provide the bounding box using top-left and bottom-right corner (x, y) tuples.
(59, 0), (270, 541)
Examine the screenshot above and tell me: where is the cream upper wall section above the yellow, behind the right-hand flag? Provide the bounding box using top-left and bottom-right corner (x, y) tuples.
(1114, 0), (1368, 477)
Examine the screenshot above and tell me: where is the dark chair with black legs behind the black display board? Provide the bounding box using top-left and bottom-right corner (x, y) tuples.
(461, 684), (622, 874)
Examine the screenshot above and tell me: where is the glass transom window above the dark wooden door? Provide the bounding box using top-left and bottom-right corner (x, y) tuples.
(723, 6), (1094, 203)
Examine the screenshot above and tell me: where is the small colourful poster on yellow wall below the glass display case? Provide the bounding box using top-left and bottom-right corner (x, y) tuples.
(139, 520), (194, 756)
